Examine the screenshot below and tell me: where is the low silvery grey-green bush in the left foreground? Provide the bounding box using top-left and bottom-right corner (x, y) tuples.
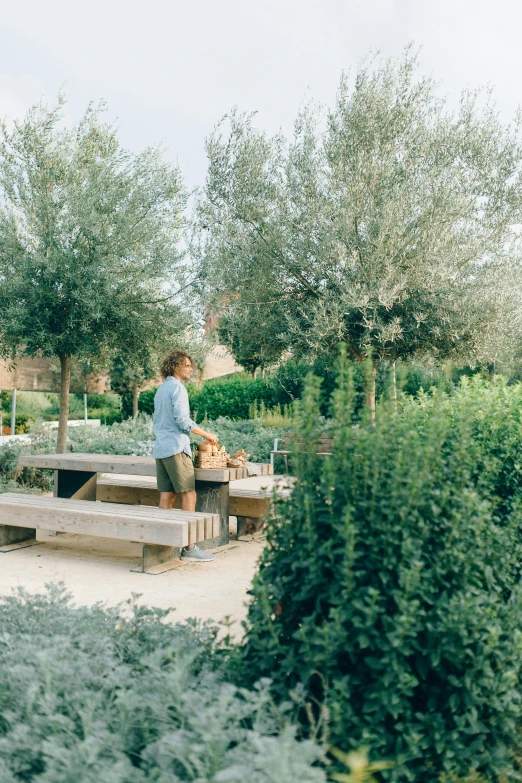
(0, 587), (325, 783)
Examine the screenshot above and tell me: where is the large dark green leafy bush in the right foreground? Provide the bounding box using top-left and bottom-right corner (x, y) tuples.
(243, 370), (522, 783)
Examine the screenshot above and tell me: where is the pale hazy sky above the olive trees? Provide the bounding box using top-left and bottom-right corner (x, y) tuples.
(0, 0), (522, 189)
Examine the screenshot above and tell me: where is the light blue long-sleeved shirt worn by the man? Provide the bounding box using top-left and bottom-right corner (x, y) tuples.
(152, 375), (196, 459)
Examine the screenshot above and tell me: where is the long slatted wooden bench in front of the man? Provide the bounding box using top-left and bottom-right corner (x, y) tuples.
(0, 492), (220, 574)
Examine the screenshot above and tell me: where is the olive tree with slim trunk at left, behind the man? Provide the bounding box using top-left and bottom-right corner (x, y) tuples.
(0, 99), (189, 452)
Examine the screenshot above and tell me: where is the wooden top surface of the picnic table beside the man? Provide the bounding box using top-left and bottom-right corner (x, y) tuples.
(18, 451), (230, 484)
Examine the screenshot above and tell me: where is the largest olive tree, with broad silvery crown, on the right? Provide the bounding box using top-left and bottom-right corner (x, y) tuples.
(196, 52), (522, 422)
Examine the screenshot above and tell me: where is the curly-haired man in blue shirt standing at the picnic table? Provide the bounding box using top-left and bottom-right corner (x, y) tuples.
(152, 350), (218, 563)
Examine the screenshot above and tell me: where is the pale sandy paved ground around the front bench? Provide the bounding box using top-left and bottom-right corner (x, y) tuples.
(0, 518), (264, 635)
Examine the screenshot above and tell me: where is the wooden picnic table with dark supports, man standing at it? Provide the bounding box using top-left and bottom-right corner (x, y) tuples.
(18, 452), (230, 549)
